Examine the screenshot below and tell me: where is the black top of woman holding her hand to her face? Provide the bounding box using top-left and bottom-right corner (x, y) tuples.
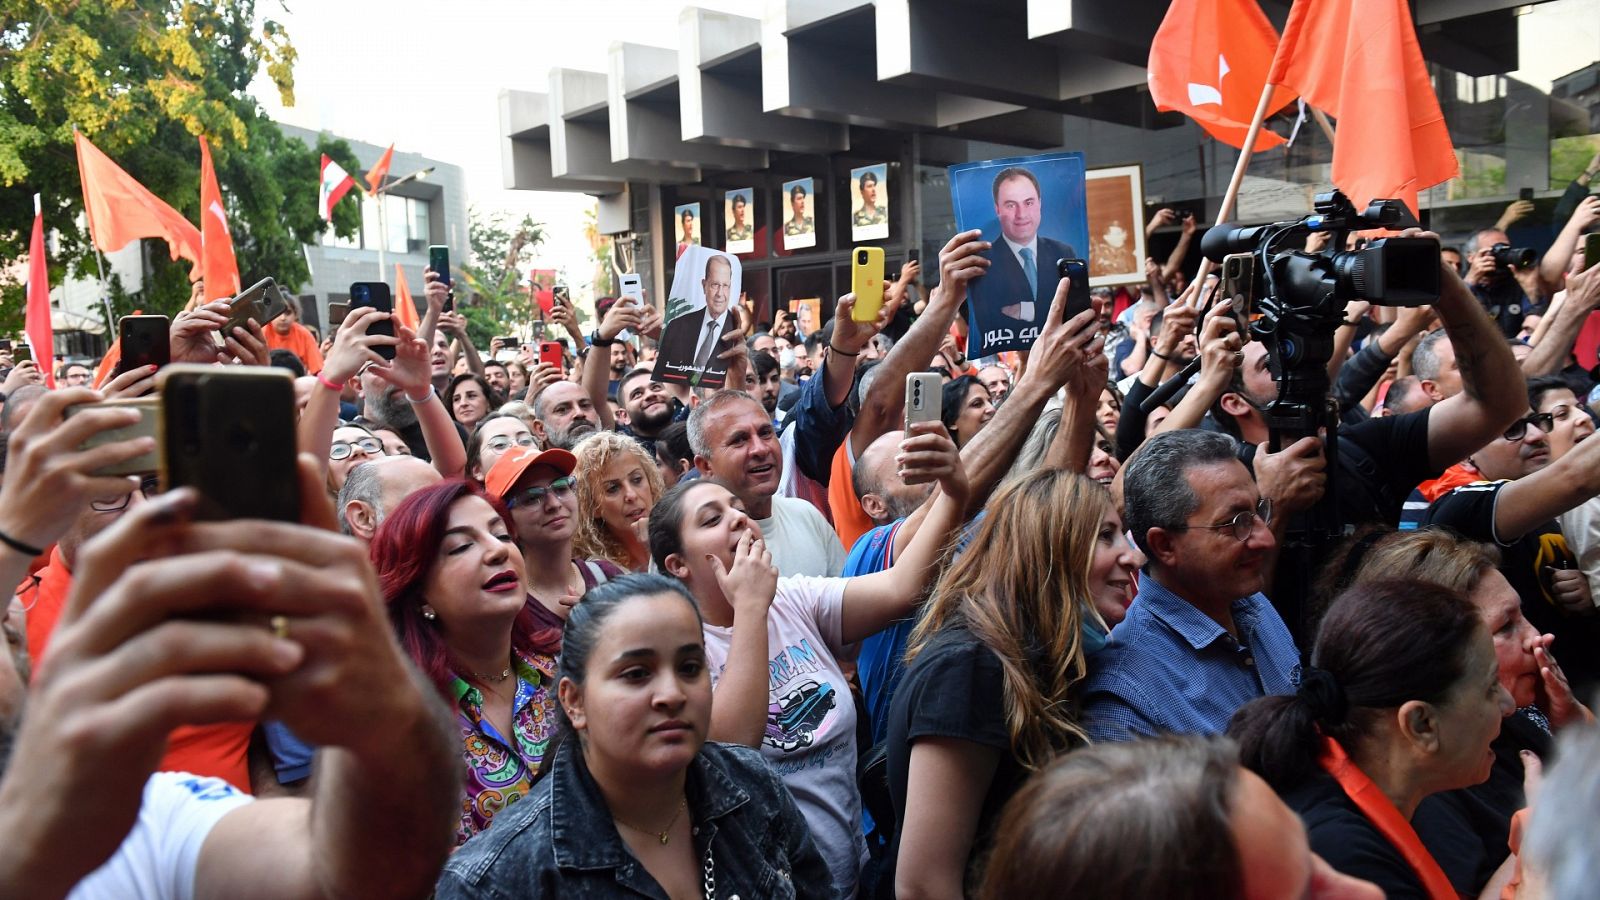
(1411, 709), (1554, 897)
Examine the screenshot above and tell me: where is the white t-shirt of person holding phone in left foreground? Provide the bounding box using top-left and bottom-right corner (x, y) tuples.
(67, 772), (254, 900)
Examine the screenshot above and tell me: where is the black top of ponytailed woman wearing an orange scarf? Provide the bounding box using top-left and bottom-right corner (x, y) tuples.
(1283, 770), (1429, 900)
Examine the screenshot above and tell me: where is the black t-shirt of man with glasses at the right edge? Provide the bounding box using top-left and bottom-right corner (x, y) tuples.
(1422, 480), (1600, 697)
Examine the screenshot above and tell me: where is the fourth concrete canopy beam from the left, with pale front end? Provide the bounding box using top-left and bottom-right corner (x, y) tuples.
(678, 6), (850, 154)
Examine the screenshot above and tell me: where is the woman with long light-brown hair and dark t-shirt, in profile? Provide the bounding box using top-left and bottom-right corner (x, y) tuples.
(883, 468), (1133, 897)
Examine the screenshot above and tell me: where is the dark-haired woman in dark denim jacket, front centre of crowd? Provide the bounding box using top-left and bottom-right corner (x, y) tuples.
(437, 575), (835, 900)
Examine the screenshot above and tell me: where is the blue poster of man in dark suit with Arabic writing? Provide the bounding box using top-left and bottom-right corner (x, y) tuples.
(950, 152), (1090, 359)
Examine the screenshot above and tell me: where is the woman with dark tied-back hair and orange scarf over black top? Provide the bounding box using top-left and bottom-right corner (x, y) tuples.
(1227, 581), (1512, 900)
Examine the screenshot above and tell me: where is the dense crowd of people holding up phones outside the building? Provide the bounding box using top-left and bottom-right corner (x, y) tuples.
(0, 169), (1600, 900)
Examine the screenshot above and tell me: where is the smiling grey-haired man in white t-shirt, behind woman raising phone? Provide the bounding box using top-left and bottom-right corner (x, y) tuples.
(690, 391), (845, 577)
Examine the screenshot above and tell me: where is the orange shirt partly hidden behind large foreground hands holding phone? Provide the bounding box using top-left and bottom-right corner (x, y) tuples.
(18, 548), (256, 794)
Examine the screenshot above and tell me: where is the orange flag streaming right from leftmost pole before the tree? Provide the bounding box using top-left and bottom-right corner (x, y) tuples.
(74, 131), (200, 266)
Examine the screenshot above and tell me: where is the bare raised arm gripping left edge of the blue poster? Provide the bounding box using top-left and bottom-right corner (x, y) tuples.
(850, 231), (989, 456)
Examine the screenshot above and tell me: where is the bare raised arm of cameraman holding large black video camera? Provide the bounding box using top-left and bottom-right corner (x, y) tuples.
(1411, 232), (1528, 469)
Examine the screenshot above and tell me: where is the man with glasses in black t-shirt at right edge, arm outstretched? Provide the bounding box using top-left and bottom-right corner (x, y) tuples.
(1422, 397), (1600, 685)
